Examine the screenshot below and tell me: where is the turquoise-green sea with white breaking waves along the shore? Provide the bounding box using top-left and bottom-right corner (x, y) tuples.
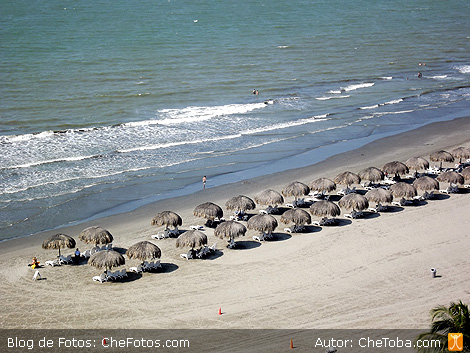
(0, 0), (470, 239)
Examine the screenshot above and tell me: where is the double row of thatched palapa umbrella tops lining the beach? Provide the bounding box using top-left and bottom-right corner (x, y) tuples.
(42, 148), (470, 270)
